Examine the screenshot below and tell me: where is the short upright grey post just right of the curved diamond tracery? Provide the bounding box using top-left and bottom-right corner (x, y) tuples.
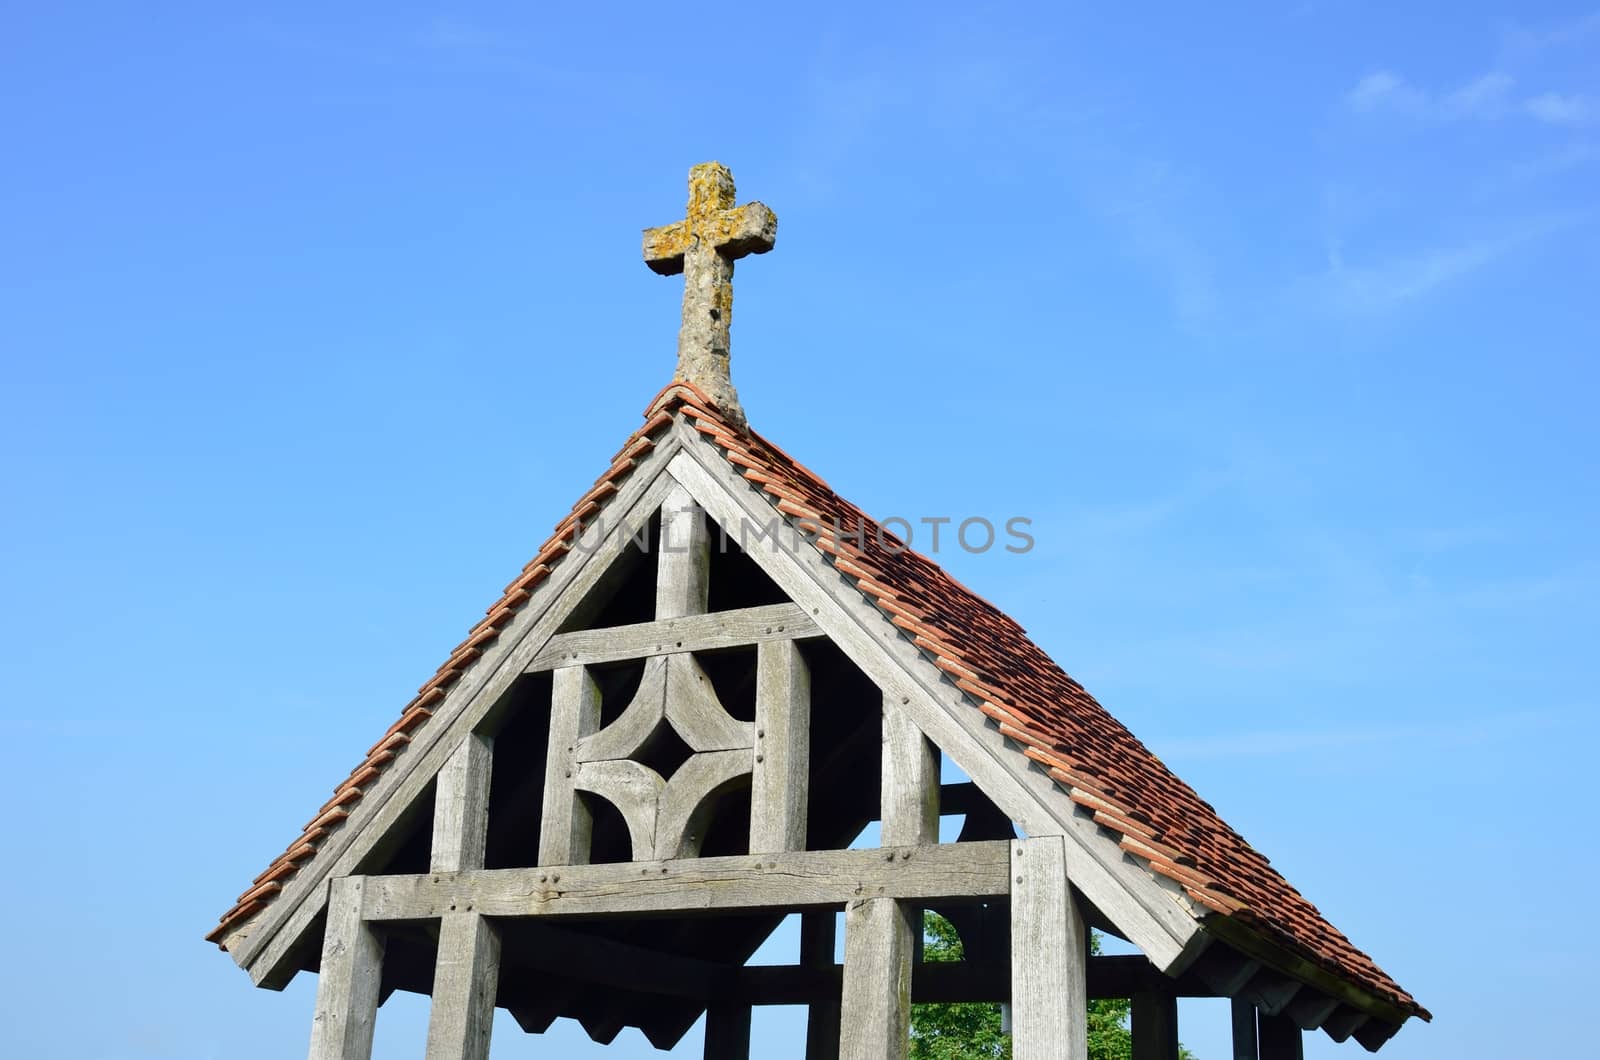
(750, 640), (811, 853)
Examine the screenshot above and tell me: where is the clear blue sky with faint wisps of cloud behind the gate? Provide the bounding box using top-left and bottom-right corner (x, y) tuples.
(0, 0), (1600, 1060)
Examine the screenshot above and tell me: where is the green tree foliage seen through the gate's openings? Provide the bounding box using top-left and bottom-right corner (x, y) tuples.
(910, 913), (1195, 1060)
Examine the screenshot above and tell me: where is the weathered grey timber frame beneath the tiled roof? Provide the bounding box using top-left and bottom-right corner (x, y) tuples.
(224, 400), (1410, 1060)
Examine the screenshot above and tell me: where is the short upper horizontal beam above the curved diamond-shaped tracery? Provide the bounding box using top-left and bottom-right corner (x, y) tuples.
(528, 604), (822, 671)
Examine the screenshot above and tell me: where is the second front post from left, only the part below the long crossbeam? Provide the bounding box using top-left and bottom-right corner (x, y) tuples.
(427, 909), (499, 1060)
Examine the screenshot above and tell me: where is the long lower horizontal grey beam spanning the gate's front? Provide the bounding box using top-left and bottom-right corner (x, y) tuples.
(363, 841), (1011, 921)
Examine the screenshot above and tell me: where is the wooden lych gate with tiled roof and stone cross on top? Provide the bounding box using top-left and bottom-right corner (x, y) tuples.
(211, 163), (1426, 1060)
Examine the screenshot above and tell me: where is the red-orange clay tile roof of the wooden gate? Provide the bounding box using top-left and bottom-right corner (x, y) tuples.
(206, 383), (1429, 1037)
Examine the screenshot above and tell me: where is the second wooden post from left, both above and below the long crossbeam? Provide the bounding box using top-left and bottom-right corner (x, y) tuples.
(427, 733), (499, 1060)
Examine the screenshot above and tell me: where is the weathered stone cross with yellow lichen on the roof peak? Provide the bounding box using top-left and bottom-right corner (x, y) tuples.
(645, 162), (778, 424)
